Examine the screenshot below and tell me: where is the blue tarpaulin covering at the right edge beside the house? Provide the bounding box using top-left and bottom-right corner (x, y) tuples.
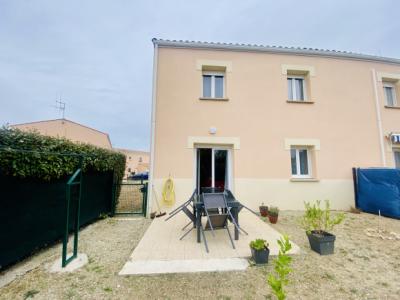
(356, 168), (400, 219)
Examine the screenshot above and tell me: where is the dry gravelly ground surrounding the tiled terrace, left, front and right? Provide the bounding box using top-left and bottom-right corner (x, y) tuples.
(0, 211), (400, 299)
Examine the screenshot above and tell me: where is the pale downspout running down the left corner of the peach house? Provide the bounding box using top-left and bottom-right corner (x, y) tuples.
(147, 39), (158, 217)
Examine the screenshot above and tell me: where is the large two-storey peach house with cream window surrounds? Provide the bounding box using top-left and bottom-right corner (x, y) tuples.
(148, 39), (400, 211)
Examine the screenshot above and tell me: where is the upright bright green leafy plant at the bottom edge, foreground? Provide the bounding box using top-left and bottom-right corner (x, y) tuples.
(267, 235), (292, 300)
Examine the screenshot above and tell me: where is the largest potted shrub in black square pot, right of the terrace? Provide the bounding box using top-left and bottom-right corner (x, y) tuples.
(301, 200), (344, 255)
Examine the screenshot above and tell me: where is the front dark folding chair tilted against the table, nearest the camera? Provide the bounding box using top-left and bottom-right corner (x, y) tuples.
(200, 193), (247, 252)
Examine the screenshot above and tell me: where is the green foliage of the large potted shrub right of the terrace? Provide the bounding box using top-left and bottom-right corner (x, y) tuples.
(301, 200), (345, 233)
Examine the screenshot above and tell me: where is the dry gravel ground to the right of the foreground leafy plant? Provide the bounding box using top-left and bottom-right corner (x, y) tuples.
(272, 212), (400, 299)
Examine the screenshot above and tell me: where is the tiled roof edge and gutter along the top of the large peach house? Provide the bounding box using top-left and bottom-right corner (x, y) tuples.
(152, 38), (400, 64)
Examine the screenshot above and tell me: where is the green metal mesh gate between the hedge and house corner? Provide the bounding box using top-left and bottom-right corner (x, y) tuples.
(113, 181), (147, 216)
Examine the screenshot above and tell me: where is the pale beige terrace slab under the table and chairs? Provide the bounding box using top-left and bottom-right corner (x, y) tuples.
(119, 211), (300, 275)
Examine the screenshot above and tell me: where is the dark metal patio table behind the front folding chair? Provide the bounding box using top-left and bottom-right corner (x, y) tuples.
(193, 188), (242, 243)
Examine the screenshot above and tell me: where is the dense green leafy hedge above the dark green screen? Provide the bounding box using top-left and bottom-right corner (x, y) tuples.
(0, 127), (126, 182)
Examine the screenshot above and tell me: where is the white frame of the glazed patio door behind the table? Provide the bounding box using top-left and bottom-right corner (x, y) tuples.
(193, 144), (233, 191)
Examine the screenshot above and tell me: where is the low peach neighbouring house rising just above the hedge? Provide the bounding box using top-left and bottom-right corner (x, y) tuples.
(10, 119), (112, 149)
